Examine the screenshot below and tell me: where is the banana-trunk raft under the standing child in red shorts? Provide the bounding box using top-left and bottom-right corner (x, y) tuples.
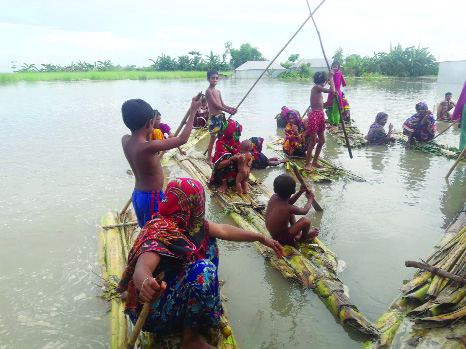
(267, 137), (364, 183)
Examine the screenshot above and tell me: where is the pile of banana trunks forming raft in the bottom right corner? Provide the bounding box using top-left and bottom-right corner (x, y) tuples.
(364, 206), (466, 348)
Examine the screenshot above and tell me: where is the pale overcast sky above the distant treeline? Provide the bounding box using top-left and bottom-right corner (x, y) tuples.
(0, 0), (466, 72)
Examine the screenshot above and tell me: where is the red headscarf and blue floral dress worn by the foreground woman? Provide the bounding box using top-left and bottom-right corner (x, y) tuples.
(118, 178), (221, 332)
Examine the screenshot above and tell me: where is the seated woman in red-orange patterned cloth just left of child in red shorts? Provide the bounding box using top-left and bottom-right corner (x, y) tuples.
(283, 110), (307, 156)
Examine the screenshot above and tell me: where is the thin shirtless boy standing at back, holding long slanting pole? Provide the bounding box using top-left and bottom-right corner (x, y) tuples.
(205, 70), (236, 166)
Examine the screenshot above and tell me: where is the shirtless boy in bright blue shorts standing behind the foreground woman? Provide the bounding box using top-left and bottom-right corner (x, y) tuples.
(121, 97), (201, 228)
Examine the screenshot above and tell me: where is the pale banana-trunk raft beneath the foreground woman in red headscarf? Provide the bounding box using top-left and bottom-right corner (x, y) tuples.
(99, 211), (237, 349)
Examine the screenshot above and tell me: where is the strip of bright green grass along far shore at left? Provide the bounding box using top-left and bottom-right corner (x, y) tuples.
(0, 71), (233, 82)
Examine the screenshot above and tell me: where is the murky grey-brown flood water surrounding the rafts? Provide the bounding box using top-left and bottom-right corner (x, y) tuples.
(0, 79), (466, 349)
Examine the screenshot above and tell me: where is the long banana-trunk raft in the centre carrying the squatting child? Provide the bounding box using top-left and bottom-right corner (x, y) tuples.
(175, 152), (378, 336)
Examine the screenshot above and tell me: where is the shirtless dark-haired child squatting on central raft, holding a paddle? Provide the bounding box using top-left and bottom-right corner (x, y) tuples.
(265, 174), (319, 245)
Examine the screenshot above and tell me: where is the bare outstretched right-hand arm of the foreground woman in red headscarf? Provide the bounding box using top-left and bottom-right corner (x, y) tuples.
(209, 222), (283, 258)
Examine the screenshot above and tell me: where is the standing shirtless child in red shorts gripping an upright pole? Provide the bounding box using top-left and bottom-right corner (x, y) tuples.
(304, 69), (335, 171)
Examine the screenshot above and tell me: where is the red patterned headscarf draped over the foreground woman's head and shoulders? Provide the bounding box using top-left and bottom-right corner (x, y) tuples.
(118, 178), (208, 292)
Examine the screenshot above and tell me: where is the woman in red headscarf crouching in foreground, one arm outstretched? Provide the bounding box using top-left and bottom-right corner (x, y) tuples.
(118, 178), (283, 348)
